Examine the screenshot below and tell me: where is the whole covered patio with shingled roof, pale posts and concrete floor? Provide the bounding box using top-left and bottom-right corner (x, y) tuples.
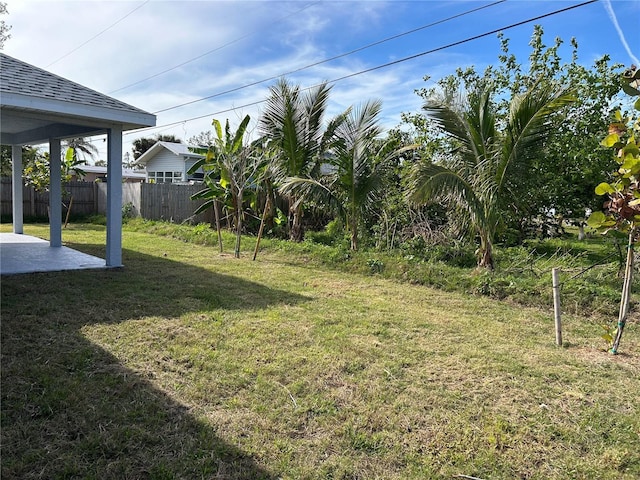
(0, 53), (156, 275)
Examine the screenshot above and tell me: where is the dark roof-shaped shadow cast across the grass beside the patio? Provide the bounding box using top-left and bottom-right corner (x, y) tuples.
(1, 246), (304, 479)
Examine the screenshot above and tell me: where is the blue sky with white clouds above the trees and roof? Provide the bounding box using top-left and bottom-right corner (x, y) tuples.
(4, 0), (640, 162)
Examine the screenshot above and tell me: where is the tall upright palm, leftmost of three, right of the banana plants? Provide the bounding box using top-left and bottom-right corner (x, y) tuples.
(259, 79), (333, 242)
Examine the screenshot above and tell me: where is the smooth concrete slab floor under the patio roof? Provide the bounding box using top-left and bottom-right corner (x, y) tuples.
(0, 233), (107, 275)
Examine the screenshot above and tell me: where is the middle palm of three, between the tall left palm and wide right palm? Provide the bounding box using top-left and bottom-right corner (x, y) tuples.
(282, 101), (408, 250)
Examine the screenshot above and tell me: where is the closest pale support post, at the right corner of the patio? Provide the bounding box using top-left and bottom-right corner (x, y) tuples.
(106, 125), (122, 267)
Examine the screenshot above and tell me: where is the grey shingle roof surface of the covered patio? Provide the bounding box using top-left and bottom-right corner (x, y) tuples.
(0, 53), (148, 115)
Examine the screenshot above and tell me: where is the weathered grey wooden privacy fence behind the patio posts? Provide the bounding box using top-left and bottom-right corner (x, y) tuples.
(0, 178), (213, 223)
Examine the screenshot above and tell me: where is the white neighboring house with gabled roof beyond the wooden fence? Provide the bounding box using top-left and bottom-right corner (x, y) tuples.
(137, 142), (204, 183)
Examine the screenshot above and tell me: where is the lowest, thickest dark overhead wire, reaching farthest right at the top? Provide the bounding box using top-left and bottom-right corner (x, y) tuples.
(124, 0), (599, 135)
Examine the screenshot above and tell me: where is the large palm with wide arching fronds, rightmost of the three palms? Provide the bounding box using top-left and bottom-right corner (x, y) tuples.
(407, 81), (574, 269)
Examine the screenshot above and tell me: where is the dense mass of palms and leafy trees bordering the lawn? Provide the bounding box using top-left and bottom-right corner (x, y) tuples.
(159, 26), (626, 274)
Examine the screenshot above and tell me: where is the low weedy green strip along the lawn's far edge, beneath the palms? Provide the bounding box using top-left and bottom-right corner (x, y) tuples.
(125, 219), (636, 322)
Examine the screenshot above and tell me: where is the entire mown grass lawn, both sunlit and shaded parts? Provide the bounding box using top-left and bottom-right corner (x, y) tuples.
(1, 225), (640, 480)
